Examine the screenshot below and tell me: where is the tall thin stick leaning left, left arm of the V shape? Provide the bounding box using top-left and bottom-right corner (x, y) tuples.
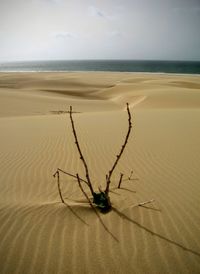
(69, 106), (94, 196)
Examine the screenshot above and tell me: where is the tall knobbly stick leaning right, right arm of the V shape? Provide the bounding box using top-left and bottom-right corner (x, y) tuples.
(105, 103), (132, 193)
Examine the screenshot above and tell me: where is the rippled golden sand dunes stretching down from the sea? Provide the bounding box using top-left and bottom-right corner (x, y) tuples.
(0, 72), (200, 274)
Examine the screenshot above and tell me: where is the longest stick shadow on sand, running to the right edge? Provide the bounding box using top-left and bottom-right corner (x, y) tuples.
(113, 208), (200, 257)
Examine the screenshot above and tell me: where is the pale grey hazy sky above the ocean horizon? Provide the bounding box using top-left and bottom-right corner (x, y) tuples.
(0, 0), (200, 62)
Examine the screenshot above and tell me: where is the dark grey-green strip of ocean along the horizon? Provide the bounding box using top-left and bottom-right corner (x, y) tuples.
(0, 60), (200, 74)
